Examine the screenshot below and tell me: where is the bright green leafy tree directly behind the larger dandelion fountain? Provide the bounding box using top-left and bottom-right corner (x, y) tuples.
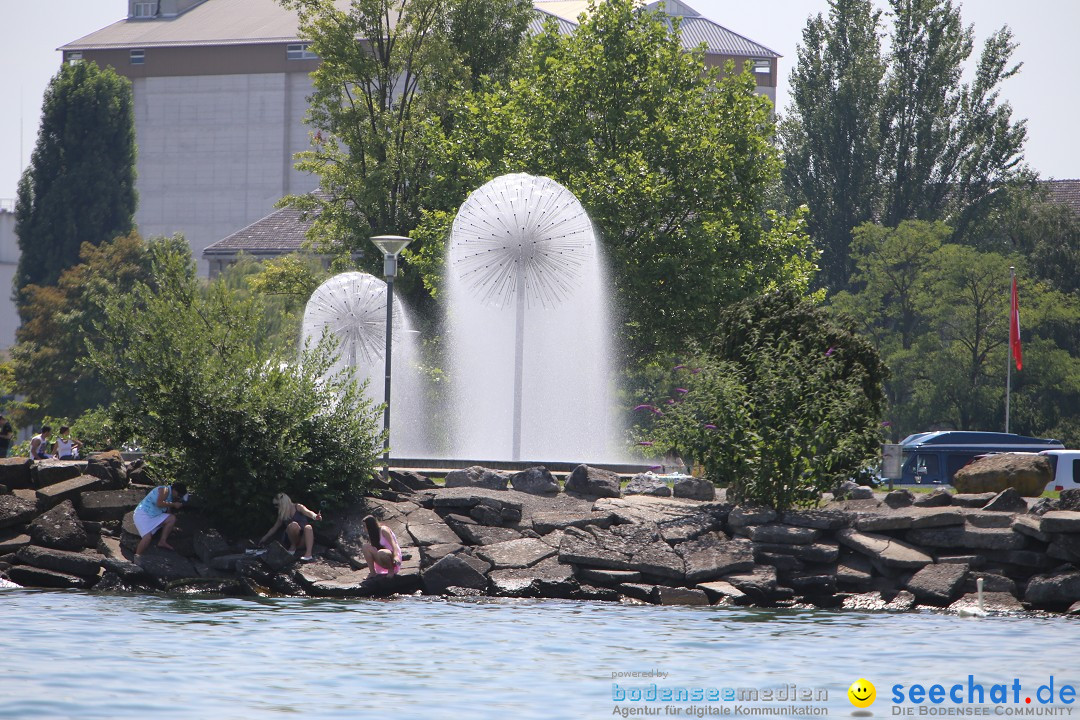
(409, 0), (812, 355)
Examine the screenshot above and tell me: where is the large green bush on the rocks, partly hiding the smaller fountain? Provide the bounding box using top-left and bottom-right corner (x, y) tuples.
(90, 247), (381, 532)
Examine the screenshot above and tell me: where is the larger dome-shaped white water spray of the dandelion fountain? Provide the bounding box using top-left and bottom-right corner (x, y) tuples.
(446, 174), (623, 462)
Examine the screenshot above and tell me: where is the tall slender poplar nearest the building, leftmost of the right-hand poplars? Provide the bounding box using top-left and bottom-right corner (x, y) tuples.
(780, 0), (886, 287)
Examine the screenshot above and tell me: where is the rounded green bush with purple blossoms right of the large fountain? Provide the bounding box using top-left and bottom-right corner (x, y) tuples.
(639, 295), (886, 510)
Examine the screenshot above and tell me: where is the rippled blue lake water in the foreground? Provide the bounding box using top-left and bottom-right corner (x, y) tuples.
(0, 589), (1080, 720)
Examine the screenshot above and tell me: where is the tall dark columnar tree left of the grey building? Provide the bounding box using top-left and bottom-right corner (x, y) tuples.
(15, 63), (136, 302)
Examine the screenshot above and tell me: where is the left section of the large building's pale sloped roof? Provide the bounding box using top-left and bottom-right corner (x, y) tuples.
(57, 0), (349, 51)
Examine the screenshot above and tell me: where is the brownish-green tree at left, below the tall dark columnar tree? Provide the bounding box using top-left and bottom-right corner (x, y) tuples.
(12, 232), (187, 423)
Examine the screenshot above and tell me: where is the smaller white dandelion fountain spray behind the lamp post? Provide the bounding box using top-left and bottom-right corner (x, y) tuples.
(301, 272), (430, 458)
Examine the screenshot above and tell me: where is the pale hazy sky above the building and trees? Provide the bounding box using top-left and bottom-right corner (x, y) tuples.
(0, 0), (1080, 200)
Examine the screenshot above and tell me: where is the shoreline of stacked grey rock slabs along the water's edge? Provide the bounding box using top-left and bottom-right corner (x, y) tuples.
(6, 453), (1080, 613)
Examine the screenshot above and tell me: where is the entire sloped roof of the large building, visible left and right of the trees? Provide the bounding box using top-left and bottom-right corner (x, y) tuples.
(57, 0), (780, 57)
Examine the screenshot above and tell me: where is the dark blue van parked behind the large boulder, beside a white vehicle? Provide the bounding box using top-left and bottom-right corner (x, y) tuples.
(900, 430), (1065, 485)
